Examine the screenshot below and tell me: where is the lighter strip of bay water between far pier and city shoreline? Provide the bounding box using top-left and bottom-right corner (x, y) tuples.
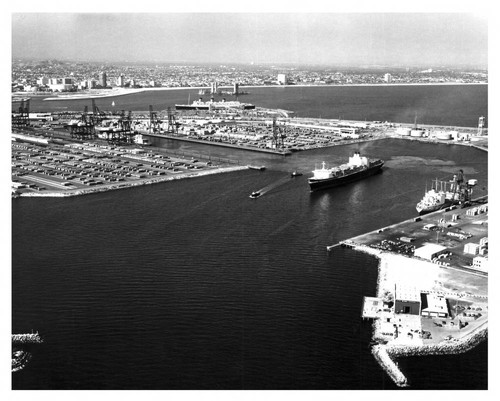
(30, 85), (488, 127)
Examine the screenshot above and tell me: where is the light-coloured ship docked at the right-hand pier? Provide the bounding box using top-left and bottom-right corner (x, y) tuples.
(416, 170), (477, 215)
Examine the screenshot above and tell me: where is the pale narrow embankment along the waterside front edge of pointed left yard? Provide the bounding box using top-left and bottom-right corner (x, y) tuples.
(15, 166), (248, 198)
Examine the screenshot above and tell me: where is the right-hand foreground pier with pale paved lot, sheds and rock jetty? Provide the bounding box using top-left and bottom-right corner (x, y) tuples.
(327, 202), (488, 386)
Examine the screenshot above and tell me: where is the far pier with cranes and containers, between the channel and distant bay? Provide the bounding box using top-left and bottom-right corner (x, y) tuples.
(12, 98), (487, 155)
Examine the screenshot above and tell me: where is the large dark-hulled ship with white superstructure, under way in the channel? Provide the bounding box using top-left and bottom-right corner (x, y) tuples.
(309, 152), (384, 191)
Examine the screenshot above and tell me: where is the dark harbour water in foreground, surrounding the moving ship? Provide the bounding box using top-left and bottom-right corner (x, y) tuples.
(12, 140), (487, 390)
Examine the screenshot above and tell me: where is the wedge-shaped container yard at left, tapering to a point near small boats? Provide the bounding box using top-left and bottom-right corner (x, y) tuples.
(12, 138), (247, 196)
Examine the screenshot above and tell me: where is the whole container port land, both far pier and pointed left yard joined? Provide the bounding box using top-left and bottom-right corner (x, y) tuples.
(12, 98), (487, 196)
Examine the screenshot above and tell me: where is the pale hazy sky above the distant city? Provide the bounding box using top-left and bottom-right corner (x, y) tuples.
(12, 13), (488, 66)
